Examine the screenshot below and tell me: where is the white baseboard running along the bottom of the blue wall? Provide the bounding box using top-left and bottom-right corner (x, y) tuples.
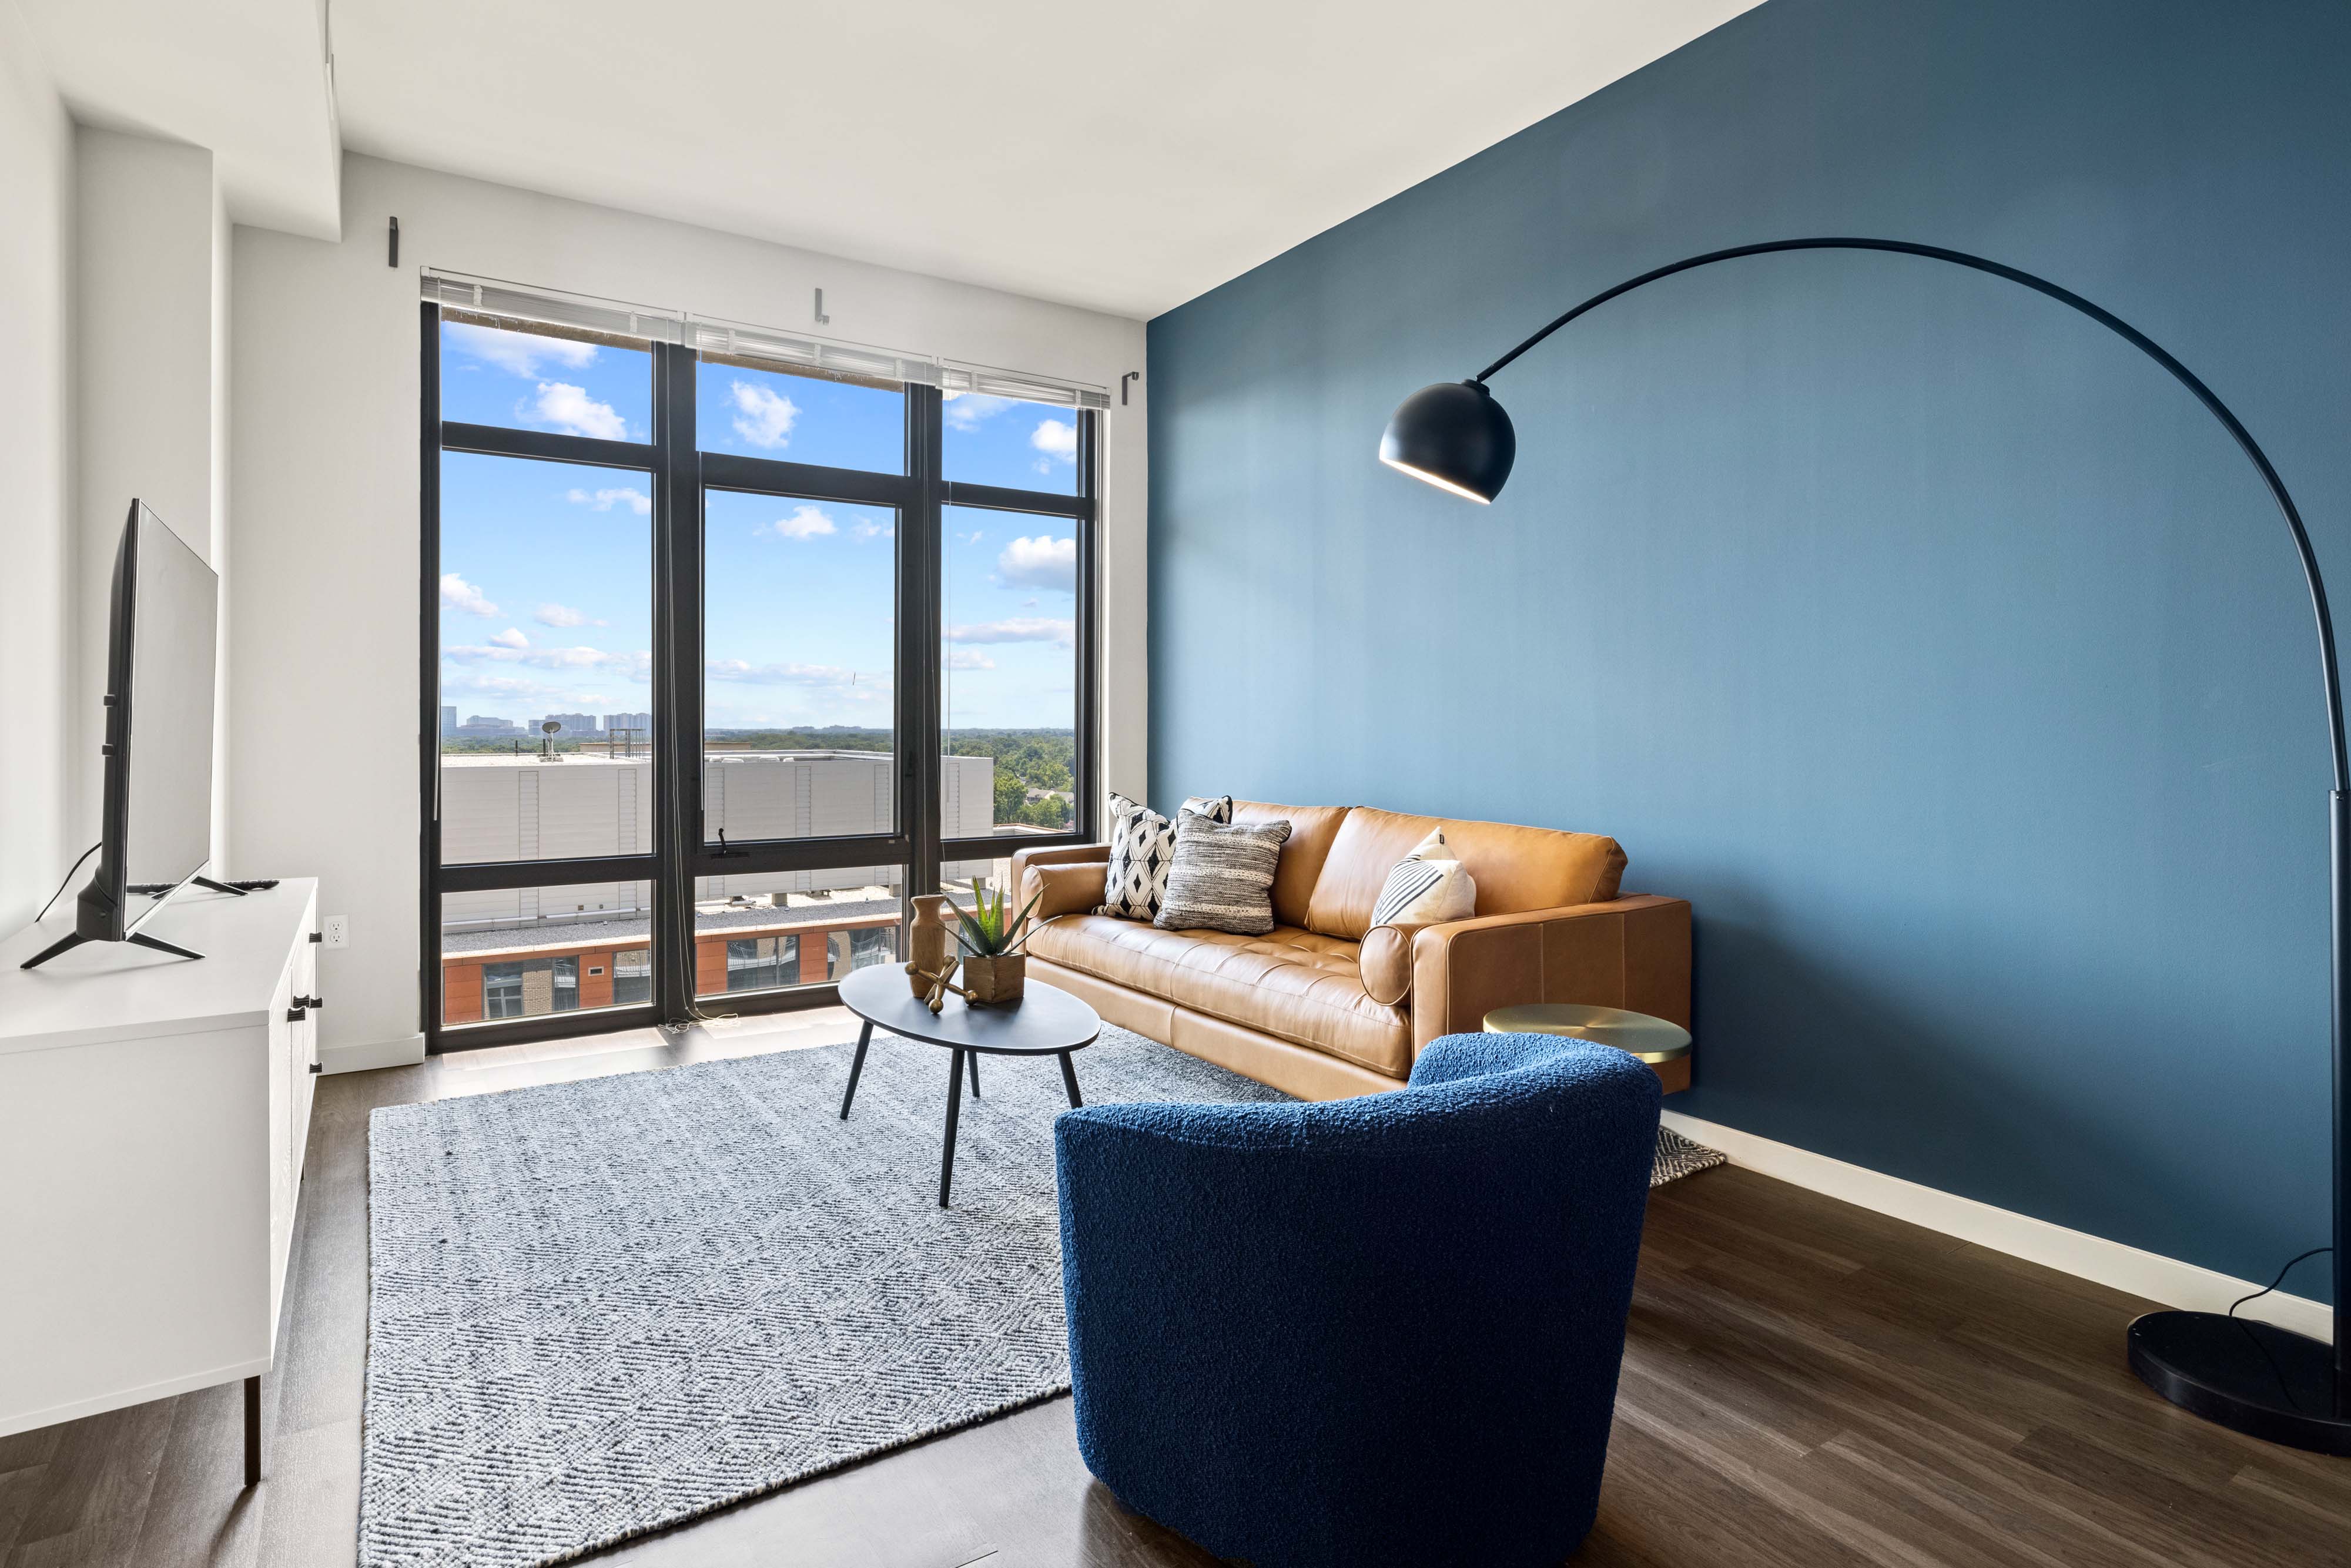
(1665, 1110), (2335, 1342)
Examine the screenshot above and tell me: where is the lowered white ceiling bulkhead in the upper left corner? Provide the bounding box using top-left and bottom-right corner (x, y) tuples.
(16, 0), (343, 240)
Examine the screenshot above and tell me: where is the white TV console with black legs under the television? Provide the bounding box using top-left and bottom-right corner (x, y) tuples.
(0, 877), (317, 1486)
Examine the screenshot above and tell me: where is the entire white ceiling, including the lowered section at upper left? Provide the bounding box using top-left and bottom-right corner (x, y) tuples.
(16, 0), (1756, 317)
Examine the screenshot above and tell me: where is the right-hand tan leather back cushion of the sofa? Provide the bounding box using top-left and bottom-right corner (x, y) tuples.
(1305, 806), (1625, 940)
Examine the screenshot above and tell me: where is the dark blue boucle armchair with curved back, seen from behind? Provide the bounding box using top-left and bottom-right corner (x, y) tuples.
(1053, 1034), (1660, 1568)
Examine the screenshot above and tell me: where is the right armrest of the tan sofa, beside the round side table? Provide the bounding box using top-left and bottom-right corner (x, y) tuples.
(1411, 893), (1690, 1056)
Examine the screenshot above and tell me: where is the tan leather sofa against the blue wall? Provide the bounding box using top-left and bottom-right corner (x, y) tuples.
(1011, 802), (1690, 1100)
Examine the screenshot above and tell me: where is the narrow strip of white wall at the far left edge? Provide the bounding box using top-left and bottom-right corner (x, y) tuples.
(0, 5), (73, 931)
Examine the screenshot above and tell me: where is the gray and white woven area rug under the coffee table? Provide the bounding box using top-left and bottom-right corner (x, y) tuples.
(360, 1025), (1721, 1568)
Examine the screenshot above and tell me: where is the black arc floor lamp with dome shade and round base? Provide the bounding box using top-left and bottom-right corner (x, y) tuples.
(1380, 237), (2351, 1455)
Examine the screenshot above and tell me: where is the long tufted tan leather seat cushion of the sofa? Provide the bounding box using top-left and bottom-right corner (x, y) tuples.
(1027, 914), (1413, 1079)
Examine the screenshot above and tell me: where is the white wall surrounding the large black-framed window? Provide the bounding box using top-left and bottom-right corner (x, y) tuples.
(230, 158), (1147, 1053)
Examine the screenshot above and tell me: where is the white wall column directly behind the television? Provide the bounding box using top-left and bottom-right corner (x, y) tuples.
(71, 125), (228, 867)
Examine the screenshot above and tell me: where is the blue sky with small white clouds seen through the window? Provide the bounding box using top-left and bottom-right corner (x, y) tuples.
(442, 322), (1077, 729)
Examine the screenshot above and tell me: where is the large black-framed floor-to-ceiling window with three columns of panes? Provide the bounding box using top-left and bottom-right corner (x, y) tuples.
(421, 277), (1100, 1048)
